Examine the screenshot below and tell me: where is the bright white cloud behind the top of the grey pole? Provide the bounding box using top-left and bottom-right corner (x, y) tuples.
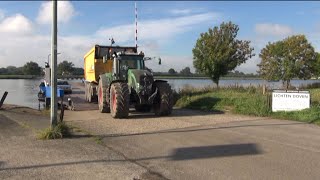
(37, 1), (77, 24)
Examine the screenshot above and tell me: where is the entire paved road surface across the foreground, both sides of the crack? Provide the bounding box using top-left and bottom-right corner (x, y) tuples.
(0, 84), (320, 180)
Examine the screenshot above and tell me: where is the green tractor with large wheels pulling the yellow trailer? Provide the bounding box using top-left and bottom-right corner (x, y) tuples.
(97, 51), (173, 118)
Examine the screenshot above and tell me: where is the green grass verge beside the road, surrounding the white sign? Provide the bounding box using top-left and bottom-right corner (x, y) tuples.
(175, 87), (320, 124)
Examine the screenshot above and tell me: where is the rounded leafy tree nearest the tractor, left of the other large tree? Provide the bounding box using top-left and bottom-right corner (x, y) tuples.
(192, 22), (254, 86)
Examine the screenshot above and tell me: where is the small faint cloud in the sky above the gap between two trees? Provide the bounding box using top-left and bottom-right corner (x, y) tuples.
(255, 23), (293, 36)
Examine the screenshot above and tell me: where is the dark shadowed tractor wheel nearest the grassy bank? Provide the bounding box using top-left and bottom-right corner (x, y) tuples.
(153, 82), (173, 116)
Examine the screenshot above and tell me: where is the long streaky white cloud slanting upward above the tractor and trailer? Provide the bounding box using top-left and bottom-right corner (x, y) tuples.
(96, 13), (219, 43)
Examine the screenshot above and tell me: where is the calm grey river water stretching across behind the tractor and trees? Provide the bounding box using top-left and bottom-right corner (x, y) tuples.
(0, 79), (320, 109)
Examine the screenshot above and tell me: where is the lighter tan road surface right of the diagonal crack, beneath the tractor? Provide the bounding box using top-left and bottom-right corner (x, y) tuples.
(66, 82), (320, 179)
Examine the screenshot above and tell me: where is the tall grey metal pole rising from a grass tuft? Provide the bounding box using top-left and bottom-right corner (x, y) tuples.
(50, 0), (58, 127)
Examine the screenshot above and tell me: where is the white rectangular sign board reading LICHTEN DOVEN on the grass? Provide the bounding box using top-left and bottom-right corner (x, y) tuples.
(272, 91), (310, 112)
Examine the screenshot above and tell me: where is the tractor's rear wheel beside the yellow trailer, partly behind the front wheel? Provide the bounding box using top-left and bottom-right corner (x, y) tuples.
(98, 78), (110, 113)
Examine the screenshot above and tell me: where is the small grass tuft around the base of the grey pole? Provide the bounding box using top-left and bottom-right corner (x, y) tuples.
(37, 122), (71, 140)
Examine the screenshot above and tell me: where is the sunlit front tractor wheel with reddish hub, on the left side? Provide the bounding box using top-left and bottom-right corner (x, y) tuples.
(110, 82), (130, 118)
